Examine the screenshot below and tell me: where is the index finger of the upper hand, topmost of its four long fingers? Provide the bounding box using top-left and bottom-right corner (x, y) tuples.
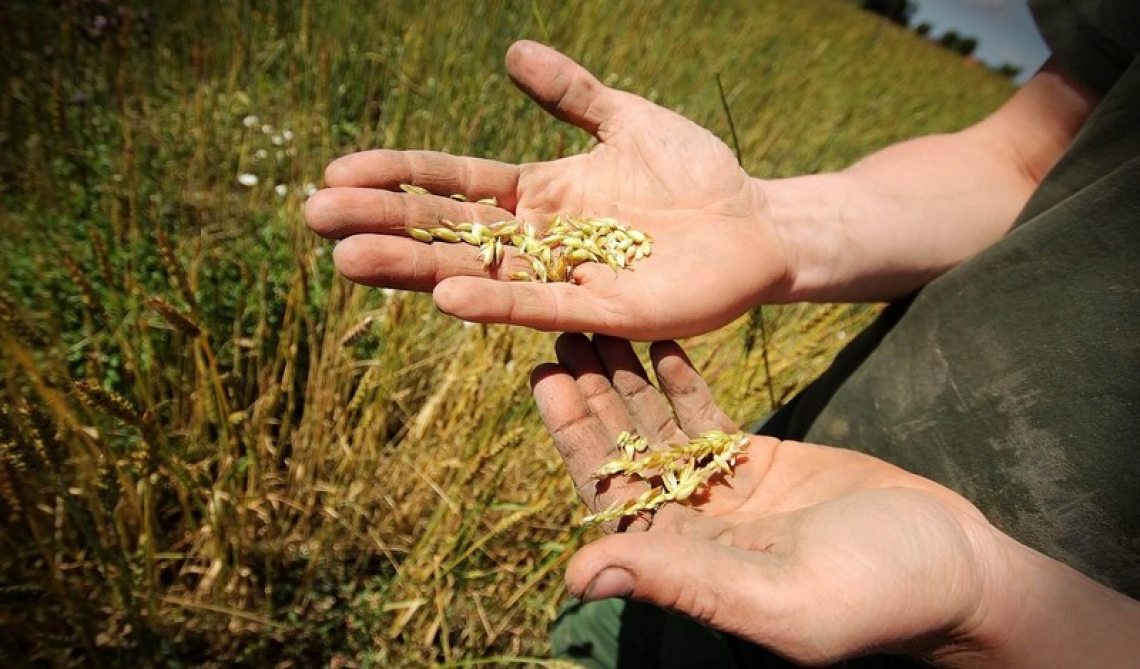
(325, 149), (519, 211)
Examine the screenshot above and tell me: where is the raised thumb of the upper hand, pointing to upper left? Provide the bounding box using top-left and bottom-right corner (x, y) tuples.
(506, 41), (620, 139)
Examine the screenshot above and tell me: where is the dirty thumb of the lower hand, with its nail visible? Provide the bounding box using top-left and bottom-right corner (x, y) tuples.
(565, 532), (765, 636)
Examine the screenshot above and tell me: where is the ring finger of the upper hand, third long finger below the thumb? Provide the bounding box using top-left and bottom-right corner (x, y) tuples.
(333, 235), (529, 292)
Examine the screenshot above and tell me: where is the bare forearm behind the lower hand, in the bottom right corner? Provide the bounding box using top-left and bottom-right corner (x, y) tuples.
(933, 536), (1140, 668)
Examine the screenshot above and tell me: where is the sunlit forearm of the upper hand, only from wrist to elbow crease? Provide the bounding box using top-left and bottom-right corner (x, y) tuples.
(764, 134), (1034, 302)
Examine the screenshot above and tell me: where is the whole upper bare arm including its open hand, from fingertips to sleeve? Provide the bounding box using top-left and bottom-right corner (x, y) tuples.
(306, 42), (1094, 340)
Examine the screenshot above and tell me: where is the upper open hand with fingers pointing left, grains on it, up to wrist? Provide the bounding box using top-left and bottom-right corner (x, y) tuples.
(306, 42), (789, 340)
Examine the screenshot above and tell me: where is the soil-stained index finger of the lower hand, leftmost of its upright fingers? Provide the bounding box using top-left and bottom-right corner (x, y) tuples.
(530, 364), (648, 531)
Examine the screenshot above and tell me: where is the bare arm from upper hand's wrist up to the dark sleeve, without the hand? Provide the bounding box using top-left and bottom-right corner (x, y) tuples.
(770, 62), (1097, 302)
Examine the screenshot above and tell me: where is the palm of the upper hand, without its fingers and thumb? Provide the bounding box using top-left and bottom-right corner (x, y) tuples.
(516, 101), (784, 338)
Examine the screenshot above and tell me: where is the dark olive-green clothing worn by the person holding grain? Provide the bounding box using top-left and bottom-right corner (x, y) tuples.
(553, 0), (1140, 669)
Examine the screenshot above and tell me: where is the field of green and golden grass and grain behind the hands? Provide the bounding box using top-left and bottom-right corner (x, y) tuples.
(0, 0), (1011, 667)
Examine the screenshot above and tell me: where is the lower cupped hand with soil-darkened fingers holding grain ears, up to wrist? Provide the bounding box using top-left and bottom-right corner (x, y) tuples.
(532, 335), (1004, 664)
